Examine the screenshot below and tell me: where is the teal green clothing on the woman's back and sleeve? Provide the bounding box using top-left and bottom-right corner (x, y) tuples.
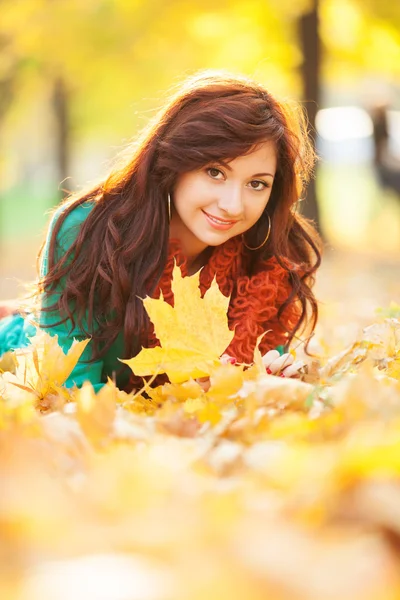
(0, 202), (283, 391)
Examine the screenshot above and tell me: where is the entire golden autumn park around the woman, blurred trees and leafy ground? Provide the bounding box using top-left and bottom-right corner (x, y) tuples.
(0, 0), (400, 600)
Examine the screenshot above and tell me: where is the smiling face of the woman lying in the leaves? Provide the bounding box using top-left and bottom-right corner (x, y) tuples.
(170, 142), (277, 258)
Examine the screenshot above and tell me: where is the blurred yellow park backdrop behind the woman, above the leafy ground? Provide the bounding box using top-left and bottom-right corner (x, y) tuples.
(0, 0), (400, 310)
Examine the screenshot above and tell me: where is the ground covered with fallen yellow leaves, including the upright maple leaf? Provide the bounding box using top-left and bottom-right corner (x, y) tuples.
(0, 252), (400, 600)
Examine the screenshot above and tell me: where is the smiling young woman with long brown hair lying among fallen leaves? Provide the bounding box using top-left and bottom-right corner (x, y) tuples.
(0, 73), (320, 390)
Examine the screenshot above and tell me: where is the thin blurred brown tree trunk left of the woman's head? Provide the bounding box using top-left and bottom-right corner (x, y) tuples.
(52, 76), (70, 200)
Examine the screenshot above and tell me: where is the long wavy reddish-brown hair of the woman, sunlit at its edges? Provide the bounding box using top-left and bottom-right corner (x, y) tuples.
(39, 73), (320, 360)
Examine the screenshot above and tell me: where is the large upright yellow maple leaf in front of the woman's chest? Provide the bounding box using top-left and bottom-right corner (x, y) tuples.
(122, 265), (234, 383)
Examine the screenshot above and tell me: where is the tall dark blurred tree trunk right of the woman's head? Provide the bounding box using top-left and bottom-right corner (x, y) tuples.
(299, 0), (323, 234)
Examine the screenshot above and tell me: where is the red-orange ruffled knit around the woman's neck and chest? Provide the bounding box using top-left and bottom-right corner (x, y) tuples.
(131, 237), (299, 383)
